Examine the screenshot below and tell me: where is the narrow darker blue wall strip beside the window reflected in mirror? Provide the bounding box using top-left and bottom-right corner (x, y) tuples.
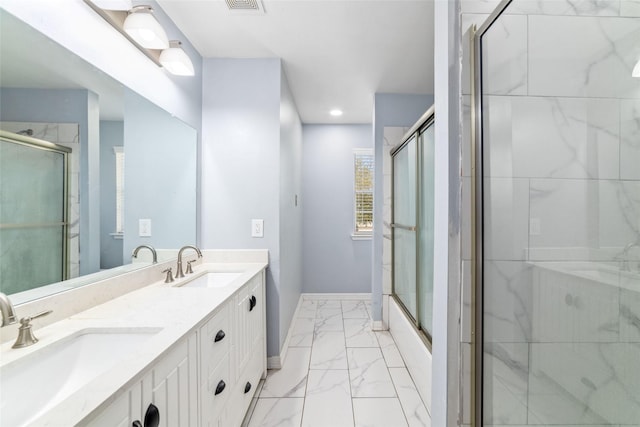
(100, 121), (123, 269)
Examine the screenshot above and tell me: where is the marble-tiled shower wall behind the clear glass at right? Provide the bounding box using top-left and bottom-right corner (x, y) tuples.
(472, 0), (640, 427)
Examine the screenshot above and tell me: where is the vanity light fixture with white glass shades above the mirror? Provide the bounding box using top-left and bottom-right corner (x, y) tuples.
(84, 0), (195, 76)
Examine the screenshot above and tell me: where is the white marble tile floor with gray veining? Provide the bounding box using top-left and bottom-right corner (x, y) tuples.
(243, 299), (431, 427)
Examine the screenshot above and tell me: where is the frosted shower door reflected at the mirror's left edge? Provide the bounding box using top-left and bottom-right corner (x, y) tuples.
(0, 133), (70, 294)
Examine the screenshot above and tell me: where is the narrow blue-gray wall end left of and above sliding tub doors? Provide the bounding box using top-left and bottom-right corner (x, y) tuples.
(371, 93), (433, 320)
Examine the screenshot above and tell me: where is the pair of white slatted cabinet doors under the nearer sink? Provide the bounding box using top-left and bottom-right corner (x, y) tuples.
(87, 333), (199, 427)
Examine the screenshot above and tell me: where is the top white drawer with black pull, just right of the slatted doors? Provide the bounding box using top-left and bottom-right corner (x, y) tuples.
(200, 304), (232, 378)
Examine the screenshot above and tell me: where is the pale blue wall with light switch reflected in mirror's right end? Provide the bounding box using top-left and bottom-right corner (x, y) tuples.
(123, 91), (198, 263)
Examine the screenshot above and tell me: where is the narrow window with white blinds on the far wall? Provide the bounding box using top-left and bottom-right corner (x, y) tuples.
(353, 149), (374, 239)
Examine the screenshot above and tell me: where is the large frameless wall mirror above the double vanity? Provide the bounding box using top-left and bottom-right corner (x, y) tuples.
(0, 10), (197, 304)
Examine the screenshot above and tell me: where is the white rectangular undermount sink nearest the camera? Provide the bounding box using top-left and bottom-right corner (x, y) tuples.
(0, 328), (160, 426)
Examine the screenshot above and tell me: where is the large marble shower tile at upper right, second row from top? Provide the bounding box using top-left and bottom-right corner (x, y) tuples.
(528, 16), (640, 98)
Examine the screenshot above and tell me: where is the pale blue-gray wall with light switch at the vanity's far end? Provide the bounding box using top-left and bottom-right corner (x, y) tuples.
(201, 59), (301, 356)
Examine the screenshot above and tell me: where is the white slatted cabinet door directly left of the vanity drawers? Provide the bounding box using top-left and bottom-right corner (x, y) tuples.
(143, 333), (198, 427)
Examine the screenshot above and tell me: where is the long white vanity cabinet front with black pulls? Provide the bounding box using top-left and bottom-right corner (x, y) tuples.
(87, 270), (267, 427)
